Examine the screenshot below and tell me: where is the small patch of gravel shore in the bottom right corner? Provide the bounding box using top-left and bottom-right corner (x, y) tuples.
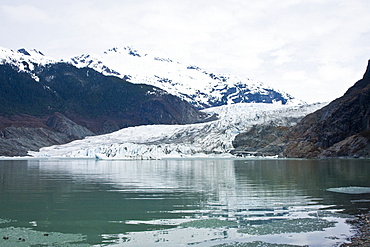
(340, 213), (370, 247)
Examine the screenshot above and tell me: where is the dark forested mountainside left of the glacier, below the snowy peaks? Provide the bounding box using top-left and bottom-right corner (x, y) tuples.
(0, 63), (211, 133)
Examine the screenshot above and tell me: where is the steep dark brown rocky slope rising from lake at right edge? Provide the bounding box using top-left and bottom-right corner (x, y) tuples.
(284, 61), (370, 157)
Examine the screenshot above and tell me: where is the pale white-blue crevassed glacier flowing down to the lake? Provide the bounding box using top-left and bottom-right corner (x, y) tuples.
(28, 103), (327, 159)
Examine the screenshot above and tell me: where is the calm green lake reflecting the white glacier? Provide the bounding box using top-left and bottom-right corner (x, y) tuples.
(0, 159), (370, 247)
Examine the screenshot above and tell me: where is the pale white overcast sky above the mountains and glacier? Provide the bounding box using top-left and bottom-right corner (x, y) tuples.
(0, 0), (370, 102)
